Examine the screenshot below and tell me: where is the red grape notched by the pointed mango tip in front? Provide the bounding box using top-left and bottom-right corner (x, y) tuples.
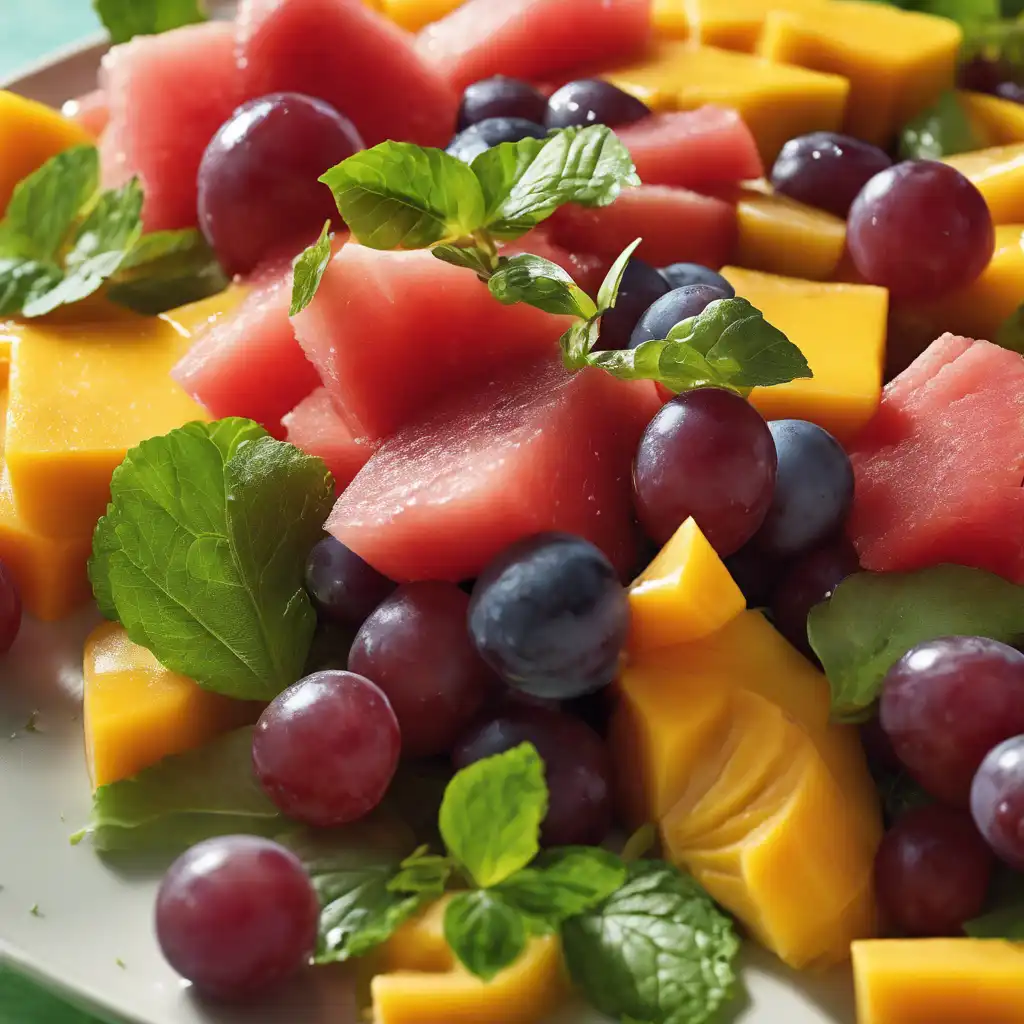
(633, 388), (778, 557)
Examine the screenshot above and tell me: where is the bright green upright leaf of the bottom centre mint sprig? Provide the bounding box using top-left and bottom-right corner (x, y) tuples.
(438, 743), (548, 889)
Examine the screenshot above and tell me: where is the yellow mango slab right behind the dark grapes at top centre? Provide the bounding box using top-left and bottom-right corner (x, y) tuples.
(602, 41), (850, 165)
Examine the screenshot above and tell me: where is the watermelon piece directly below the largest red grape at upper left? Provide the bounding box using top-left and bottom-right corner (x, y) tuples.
(171, 262), (319, 437)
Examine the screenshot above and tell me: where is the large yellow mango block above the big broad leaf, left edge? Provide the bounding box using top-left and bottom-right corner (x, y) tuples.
(5, 316), (208, 537)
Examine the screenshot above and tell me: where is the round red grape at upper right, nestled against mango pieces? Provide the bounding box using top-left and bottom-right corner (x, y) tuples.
(847, 160), (995, 301)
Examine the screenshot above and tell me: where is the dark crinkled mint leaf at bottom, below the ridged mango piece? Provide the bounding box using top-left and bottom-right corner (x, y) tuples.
(562, 860), (739, 1024)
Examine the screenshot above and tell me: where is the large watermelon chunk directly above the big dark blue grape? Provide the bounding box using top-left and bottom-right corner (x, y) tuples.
(327, 358), (658, 581)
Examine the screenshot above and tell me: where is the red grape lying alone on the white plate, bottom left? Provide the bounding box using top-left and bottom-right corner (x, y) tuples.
(156, 836), (319, 999)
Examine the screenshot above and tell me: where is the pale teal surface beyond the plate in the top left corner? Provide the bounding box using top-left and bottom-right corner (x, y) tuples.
(0, 0), (100, 78)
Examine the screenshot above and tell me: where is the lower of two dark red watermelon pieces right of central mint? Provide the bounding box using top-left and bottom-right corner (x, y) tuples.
(548, 185), (736, 268)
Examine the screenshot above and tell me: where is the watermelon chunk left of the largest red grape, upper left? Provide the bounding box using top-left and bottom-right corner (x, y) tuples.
(100, 22), (246, 231)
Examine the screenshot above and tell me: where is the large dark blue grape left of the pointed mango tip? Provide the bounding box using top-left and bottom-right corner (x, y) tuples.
(469, 532), (629, 699)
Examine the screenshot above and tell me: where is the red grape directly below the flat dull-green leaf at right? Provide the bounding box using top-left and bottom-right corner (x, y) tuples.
(881, 637), (1024, 807)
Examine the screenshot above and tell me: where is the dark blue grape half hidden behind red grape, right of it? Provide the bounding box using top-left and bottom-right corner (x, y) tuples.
(753, 420), (853, 558)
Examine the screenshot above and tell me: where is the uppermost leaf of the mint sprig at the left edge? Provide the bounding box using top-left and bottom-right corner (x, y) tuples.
(0, 145), (99, 263)
